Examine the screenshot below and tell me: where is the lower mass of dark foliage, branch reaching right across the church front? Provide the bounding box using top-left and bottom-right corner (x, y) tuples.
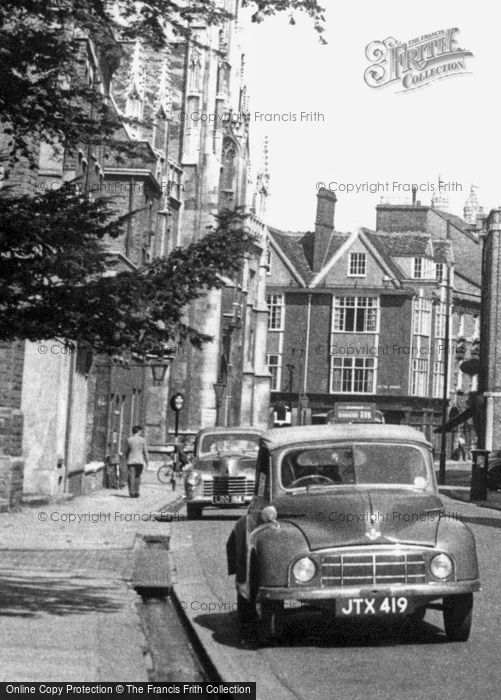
(0, 190), (253, 355)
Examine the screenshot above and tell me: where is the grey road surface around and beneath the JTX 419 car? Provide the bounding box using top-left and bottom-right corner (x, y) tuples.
(172, 498), (501, 700)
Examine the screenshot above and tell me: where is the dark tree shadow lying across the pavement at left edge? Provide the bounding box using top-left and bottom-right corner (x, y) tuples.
(0, 573), (123, 618)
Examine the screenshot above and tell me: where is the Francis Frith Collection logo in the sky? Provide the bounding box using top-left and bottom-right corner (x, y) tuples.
(364, 27), (473, 92)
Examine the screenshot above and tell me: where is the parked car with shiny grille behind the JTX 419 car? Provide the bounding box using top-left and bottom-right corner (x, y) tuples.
(184, 428), (262, 519)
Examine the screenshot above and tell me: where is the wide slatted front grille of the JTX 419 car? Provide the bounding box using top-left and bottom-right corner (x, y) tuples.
(321, 552), (426, 586)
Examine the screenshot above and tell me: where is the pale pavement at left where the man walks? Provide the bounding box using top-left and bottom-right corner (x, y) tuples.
(0, 471), (182, 682)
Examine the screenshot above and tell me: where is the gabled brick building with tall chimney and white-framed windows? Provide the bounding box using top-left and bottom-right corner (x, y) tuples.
(267, 190), (480, 448)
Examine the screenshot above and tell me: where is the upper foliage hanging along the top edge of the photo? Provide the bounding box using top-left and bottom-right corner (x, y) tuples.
(0, 0), (323, 159)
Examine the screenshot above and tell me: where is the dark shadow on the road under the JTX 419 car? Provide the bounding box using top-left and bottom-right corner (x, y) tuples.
(194, 611), (446, 649)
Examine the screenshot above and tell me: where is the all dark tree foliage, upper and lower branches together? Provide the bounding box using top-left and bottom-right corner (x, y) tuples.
(0, 0), (323, 353)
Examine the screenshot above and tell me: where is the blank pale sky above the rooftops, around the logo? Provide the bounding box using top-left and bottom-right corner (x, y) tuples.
(244, 0), (501, 231)
